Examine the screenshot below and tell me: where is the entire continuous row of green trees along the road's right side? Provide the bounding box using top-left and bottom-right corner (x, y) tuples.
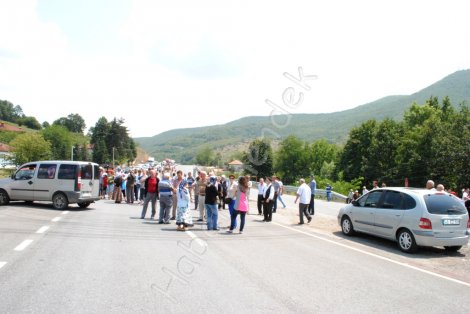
(243, 97), (470, 191)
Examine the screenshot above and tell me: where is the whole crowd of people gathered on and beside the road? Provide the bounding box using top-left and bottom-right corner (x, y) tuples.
(100, 168), (470, 233)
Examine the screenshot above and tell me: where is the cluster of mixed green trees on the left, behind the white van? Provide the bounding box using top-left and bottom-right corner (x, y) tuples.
(0, 106), (137, 165)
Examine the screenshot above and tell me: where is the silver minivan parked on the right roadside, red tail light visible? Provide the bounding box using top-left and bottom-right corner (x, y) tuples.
(338, 188), (470, 252)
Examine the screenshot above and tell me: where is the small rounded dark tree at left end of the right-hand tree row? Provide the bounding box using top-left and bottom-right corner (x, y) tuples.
(242, 138), (273, 178)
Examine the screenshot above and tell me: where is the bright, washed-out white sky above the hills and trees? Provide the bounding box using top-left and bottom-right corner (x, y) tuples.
(0, 0), (470, 137)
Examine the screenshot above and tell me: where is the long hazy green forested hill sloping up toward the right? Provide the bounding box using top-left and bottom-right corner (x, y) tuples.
(135, 70), (470, 162)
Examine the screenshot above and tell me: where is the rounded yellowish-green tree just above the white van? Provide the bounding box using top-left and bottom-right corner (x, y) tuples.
(10, 132), (51, 165)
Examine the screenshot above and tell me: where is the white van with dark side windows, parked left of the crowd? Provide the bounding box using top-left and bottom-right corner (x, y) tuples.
(0, 160), (100, 209)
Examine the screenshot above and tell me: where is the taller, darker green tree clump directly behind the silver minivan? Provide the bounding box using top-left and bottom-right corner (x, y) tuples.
(336, 97), (470, 189)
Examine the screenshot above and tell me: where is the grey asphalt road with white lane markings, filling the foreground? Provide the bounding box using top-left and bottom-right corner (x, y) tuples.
(0, 195), (470, 313)
